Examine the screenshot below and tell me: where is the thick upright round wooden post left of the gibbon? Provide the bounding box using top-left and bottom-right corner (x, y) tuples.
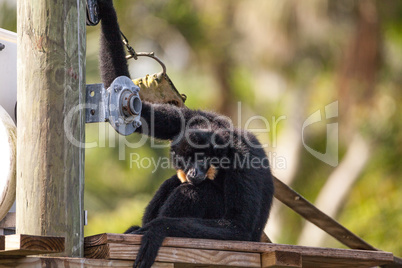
(16, 0), (86, 257)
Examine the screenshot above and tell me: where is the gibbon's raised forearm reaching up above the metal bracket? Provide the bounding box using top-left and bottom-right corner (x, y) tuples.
(99, 0), (130, 88)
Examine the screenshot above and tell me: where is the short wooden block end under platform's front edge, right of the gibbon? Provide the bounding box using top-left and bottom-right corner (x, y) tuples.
(261, 251), (302, 268)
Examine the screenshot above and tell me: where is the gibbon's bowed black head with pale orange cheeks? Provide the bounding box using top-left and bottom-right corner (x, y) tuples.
(171, 129), (228, 185)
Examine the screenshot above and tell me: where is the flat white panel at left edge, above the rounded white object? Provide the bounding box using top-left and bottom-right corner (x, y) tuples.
(0, 29), (17, 122)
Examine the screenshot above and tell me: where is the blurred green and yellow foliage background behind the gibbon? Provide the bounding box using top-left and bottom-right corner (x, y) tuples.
(0, 0), (402, 256)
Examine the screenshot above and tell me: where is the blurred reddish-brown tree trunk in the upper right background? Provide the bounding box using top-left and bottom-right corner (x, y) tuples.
(338, 0), (381, 137)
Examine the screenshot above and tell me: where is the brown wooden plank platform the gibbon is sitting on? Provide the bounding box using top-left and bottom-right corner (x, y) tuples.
(81, 234), (393, 267)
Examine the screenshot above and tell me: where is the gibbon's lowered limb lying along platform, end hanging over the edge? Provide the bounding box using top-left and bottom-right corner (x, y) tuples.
(133, 174), (262, 268)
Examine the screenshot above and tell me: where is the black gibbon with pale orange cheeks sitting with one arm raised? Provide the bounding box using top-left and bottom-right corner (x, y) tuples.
(100, 0), (274, 268)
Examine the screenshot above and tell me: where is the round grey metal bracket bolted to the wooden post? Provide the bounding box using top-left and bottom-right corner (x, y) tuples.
(85, 76), (142, 136)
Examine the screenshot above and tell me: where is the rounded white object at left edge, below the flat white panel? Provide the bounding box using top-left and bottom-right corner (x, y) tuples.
(0, 105), (17, 220)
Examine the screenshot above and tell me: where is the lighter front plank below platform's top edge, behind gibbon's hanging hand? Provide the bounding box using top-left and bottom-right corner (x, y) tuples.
(85, 244), (261, 267)
